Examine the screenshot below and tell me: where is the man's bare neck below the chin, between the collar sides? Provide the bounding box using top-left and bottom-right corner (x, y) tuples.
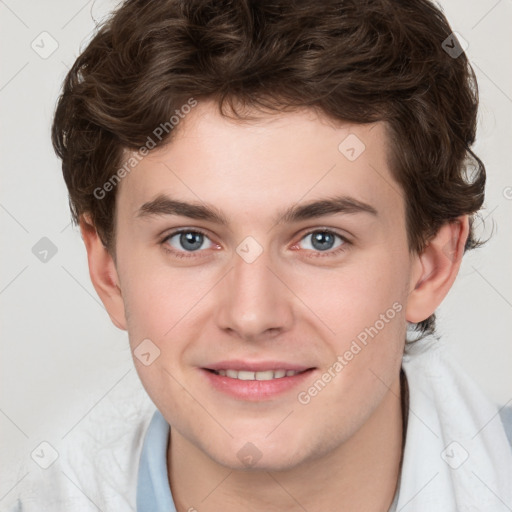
(167, 377), (407, 512)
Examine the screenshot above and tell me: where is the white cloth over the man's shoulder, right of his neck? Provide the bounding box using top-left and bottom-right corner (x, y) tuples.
(397, 338), (512, 512)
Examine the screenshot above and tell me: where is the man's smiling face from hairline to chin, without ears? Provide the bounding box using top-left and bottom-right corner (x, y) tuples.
(116, 102), (411, 470)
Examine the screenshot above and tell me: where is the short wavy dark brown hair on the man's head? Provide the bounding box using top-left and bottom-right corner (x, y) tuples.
(52, 0), (485, 340)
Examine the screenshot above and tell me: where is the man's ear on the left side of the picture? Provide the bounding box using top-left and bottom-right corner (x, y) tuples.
(80, 214), (126, 330)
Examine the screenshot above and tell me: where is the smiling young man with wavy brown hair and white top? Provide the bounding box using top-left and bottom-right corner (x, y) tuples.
(13, 0), (512, 512)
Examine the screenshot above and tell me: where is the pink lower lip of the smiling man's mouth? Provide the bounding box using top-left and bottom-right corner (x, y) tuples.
(200, 368), (314, 402)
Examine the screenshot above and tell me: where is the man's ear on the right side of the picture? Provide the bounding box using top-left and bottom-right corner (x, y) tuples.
(406, 215), (469, 323)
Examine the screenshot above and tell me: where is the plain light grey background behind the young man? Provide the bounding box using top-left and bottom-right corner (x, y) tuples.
(0, 0), (512, 509)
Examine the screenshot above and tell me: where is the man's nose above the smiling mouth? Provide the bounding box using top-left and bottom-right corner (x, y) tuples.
(217, 245), (294, 341)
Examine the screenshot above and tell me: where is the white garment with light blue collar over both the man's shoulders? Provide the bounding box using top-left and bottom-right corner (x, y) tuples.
(4, 340), (512, 512)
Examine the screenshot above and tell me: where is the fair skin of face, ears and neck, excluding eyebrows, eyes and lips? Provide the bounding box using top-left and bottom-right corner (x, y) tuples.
(81, 101), (468, 512)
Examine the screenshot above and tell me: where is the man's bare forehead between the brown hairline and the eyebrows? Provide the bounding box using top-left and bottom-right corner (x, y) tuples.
(118, 101), (403, 227)
